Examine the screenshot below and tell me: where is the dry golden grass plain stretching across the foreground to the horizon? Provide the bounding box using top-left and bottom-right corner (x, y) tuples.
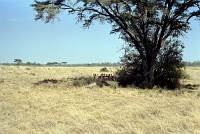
(0, 66), (200, 134)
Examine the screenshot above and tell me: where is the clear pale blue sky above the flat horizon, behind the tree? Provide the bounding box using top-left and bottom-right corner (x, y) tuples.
(0, 0), (200, 63)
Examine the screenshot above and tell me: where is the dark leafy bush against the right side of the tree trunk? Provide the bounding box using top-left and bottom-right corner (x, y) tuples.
(154, 41), (184, 89)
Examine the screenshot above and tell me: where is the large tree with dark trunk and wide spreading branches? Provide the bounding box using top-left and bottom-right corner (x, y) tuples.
(32, 0), (200, 88)
